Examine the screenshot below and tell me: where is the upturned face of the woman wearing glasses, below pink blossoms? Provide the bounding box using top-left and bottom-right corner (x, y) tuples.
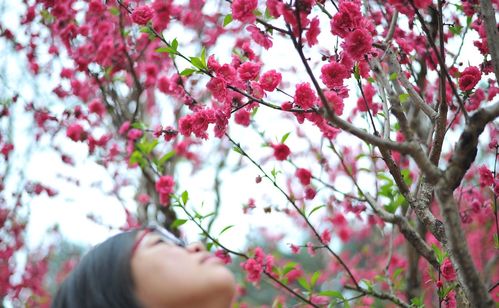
(131, 231), (235, 308)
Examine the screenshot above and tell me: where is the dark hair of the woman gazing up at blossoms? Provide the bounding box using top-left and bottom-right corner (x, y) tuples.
(52, 230), (141, 308)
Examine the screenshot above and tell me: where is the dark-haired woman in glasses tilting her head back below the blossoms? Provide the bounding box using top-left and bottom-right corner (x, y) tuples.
(52, 226), (235, 308)
